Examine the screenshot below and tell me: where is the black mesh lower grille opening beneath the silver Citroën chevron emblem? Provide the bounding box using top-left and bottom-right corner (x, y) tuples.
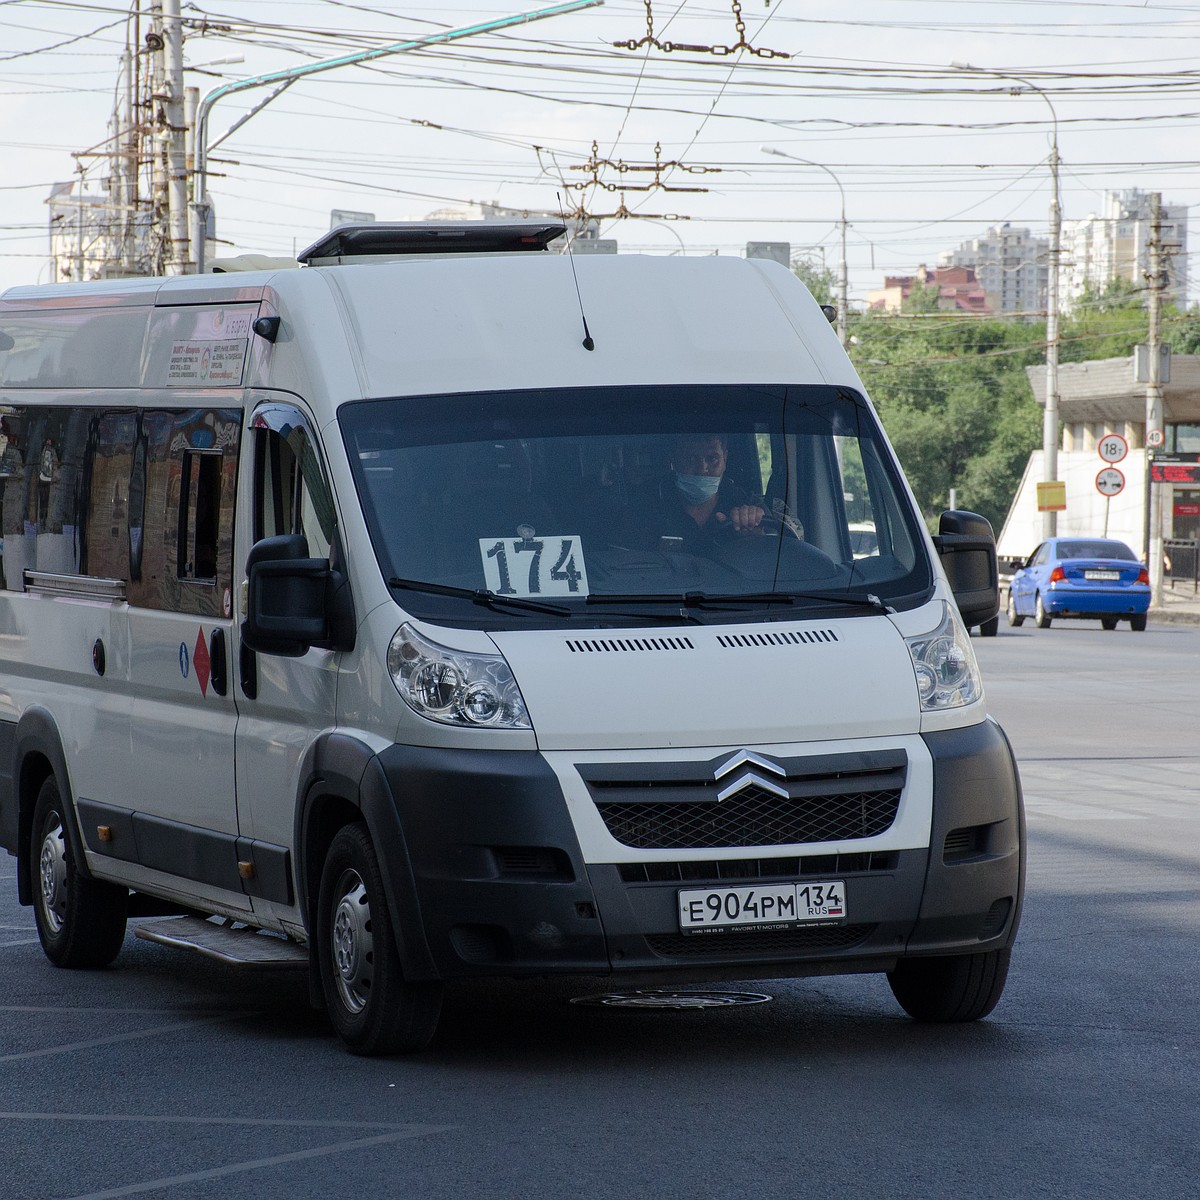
(596, 786), (900, 850)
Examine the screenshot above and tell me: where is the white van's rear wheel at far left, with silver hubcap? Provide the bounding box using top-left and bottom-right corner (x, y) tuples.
(29, 775), (130, 967)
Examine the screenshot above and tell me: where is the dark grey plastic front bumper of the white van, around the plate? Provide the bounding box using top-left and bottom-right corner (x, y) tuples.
(368, 721), (1025, 980)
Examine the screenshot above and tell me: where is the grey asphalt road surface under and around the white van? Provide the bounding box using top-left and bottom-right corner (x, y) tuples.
(0, 623), (1200, 1200)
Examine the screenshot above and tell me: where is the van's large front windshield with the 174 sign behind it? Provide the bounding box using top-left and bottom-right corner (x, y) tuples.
(338, 385), (932, 628)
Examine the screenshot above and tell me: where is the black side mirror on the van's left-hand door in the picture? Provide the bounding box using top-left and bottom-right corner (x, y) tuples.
(241, 534), (331, 658)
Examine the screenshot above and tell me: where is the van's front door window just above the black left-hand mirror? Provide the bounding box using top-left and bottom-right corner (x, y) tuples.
(254, 408), (336, 558)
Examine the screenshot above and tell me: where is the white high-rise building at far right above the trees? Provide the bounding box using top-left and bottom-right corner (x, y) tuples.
(1061, 188), (1188, 310)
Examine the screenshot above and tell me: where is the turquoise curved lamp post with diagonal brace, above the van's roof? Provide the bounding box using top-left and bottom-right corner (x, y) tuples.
(192, 0), (604, 275)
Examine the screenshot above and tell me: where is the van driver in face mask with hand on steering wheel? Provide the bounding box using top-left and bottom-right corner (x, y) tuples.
(634, 433), (766, 554)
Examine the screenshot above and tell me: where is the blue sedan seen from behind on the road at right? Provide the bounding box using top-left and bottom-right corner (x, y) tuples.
(1008, 538), (1150, 631)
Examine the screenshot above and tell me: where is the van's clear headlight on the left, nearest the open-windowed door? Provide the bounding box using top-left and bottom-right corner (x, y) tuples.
(388, 625), (533, 730)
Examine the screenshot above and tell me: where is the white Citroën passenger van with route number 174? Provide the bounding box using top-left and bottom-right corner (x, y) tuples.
(0, 222), (1025, 1054)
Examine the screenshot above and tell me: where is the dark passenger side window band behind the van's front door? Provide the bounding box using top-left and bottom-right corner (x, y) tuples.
(0, 406), (241, 617)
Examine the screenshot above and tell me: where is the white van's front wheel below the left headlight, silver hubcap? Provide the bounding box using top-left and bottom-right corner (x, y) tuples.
(317, 824), (442, 1055)
